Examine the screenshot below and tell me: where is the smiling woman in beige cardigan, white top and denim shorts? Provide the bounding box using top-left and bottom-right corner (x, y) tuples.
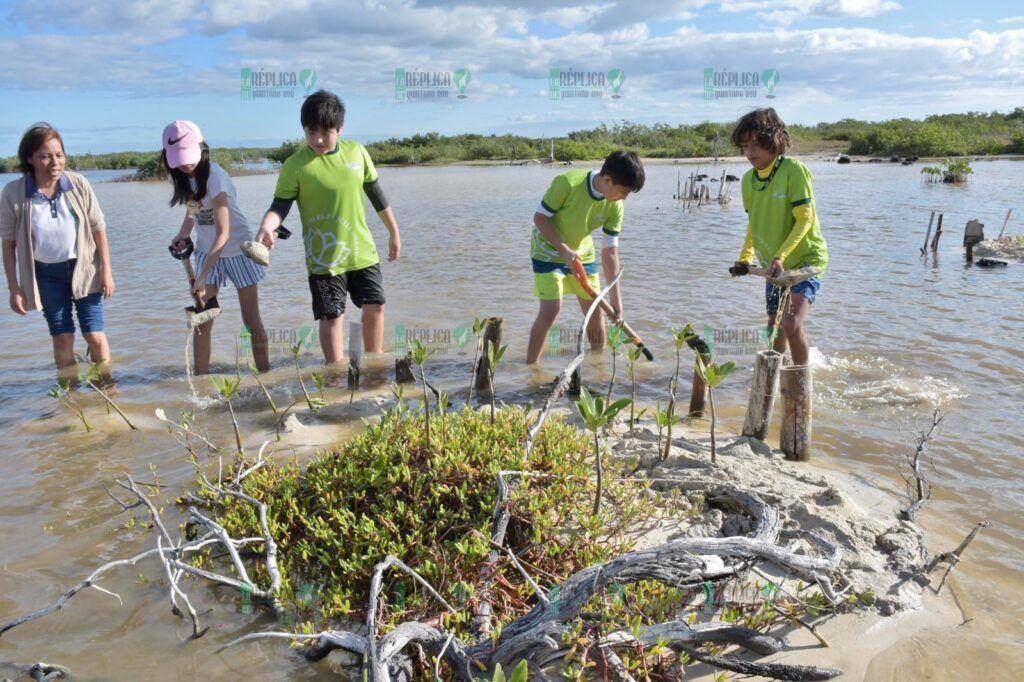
(0, 123), (115, 370)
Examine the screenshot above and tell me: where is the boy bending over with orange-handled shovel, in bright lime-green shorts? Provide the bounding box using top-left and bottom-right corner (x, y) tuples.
(526, 152), (645, 365)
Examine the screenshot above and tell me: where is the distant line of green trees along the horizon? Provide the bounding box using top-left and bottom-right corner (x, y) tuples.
(0, 106), (1024, 174)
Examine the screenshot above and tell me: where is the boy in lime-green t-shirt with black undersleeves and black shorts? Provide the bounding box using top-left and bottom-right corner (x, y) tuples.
(256, 90), (401, 365)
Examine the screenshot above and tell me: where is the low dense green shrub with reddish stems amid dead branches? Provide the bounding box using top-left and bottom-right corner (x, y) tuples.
(203, 409), (649, 636)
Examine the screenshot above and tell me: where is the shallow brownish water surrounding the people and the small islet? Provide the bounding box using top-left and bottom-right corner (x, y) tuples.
(0, 161), (1024, 680)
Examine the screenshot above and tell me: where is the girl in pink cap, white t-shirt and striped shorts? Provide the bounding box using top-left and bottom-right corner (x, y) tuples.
(161, 121), (270, 374)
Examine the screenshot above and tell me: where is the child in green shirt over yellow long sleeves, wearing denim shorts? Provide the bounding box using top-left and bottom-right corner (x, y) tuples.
(732, 108), (828, 365)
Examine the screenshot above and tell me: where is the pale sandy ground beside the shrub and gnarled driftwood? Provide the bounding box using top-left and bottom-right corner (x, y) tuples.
(593, 413), (967, 680)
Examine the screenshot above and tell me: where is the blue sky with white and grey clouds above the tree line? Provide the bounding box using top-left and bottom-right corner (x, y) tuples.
(0, 0), (1024, 156)
